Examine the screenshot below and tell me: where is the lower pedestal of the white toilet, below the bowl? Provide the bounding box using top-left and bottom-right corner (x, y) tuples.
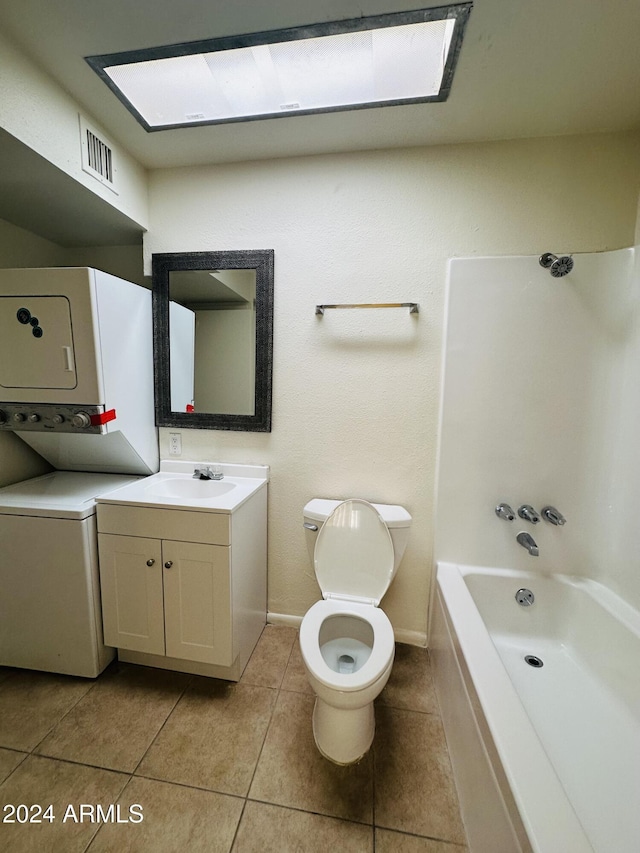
(313, 697), (376, 765)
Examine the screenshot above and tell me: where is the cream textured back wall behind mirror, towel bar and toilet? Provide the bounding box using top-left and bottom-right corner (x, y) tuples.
(145, 134), (640, 641)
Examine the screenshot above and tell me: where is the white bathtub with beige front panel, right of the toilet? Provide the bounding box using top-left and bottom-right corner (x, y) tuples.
(430, 563), (640, 853)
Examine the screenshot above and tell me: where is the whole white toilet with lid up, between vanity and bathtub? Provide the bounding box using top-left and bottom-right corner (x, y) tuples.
(300, 498), (411, 764)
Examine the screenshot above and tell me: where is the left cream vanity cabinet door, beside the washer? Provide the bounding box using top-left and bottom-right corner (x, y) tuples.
(98, 533), (165, 655)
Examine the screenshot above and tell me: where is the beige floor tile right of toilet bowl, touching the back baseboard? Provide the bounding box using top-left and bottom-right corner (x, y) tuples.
(376, 643), (440, 714)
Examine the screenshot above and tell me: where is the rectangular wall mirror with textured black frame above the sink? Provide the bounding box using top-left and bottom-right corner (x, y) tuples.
(152, 249), (274, 432)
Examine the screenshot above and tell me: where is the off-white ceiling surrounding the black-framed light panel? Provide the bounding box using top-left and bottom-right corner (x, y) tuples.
(0, 0), (640, 168)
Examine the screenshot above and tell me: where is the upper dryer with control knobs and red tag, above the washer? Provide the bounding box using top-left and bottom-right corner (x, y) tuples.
(0, 267), (159, 474)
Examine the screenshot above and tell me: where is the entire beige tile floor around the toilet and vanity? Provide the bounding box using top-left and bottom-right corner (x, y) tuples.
(0, 626), (466, 853)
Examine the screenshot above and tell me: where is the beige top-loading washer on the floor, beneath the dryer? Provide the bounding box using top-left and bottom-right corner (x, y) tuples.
(0, 471), (138, 678)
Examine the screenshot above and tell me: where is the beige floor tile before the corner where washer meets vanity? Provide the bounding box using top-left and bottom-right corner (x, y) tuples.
(37, 664), (191, 773)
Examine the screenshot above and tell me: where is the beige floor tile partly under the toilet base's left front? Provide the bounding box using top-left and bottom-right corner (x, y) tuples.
(249, 691), (373, 823)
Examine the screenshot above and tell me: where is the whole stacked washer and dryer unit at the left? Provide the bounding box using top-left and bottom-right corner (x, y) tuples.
(0, 268), (159, 677)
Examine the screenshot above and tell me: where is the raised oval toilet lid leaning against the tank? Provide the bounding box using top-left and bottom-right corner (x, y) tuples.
(313, 498), (394, 607)
